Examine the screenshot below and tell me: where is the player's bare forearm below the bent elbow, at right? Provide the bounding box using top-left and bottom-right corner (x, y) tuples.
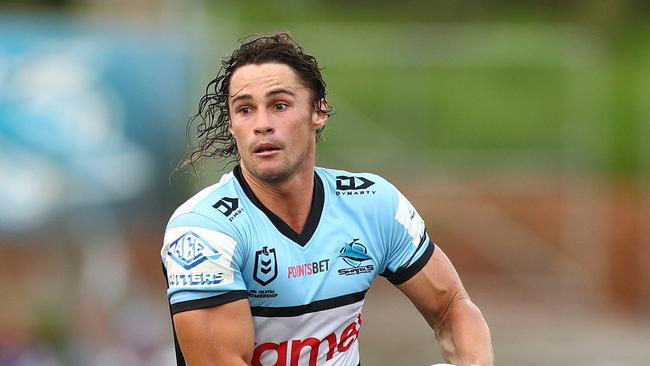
(432, 298), (494, 366)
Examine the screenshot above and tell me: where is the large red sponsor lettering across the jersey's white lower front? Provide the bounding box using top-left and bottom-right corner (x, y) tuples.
(252, 314), (362, 366)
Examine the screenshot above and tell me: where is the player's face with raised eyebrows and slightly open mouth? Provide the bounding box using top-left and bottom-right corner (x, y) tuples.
(228, 63), (327, 183)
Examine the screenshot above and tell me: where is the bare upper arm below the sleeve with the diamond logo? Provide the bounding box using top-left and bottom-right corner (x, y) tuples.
(174, 299), (255, 366)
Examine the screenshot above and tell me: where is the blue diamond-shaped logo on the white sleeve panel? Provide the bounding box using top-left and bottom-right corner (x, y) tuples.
(167, 231), (221, 270)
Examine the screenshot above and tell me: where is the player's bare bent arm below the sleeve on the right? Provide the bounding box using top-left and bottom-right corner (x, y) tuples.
(397, 247), (494, 366)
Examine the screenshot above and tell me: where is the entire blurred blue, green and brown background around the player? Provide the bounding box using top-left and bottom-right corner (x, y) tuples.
(0, 0), (650, 366)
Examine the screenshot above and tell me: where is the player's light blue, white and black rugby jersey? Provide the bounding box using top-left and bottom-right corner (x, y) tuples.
(161, 166), (434, 366)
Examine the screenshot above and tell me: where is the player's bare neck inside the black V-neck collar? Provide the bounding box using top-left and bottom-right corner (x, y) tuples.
(241, 165), (314, 234)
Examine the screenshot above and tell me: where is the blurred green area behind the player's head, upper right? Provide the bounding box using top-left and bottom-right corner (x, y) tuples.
(197, 1), (650, 178)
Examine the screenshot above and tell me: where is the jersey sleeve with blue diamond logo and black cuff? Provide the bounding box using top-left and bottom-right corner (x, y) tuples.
(160, 212), (248, 314)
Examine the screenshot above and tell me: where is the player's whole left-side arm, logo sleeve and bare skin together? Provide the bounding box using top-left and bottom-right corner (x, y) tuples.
(161, 212), (255, 366)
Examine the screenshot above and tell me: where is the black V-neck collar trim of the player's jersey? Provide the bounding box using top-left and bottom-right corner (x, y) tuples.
(233, 165), (325, 246)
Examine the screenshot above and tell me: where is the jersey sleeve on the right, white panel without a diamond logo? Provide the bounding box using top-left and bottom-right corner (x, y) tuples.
(381, 186), (435, 285)
